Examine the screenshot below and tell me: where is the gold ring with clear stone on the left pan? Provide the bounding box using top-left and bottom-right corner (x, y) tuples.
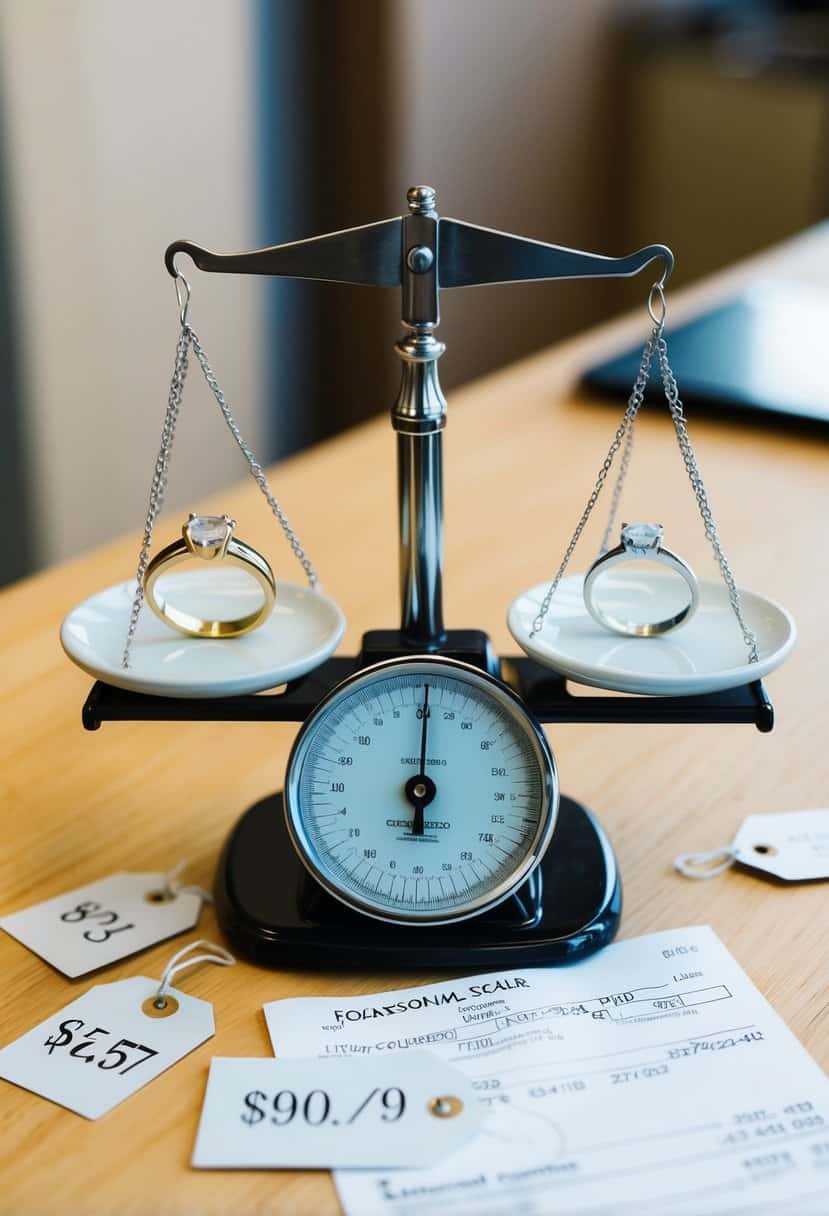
(143, 513), (276, 637)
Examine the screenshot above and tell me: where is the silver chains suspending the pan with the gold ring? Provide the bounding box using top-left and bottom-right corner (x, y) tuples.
(122, 275), (318, 669)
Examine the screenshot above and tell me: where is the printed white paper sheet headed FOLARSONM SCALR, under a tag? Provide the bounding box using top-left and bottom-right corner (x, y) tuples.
(265, 928), (829, 1216)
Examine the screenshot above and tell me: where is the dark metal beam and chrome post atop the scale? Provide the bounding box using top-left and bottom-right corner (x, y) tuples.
(164, 186), (673, 651)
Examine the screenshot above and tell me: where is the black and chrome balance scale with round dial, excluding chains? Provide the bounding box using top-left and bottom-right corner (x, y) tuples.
(63, 186), (777, 970)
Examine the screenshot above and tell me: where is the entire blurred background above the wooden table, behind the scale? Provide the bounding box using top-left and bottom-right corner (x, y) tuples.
(0, 0), (829, 581)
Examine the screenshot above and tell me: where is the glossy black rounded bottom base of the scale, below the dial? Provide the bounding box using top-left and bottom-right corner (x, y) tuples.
(215, 794), (621, 972)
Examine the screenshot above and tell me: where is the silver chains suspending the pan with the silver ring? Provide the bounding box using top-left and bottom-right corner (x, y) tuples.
(530, 290), (760, 663)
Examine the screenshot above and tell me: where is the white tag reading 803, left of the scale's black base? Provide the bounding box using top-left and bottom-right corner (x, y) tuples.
(0, 873), (202, 979)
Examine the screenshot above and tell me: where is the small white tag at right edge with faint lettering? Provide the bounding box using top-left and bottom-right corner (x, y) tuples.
(732, 809), (829, 883)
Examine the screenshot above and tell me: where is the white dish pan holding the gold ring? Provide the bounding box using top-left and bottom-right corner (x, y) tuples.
(61, 572), (345, 697)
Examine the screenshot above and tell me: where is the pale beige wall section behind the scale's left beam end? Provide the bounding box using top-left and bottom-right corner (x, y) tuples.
(0, 0), (267, 565)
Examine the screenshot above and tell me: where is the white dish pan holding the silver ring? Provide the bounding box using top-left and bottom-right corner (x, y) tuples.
(507, 570), (797, 697)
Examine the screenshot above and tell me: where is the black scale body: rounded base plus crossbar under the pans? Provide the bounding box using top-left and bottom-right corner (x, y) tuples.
(83, 630), (774, 972)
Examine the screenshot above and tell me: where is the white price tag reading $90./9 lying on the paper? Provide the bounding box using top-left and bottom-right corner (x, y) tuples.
(192, 1051), (483, 1170)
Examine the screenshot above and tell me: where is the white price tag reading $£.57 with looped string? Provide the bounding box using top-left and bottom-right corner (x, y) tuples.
(0, 975), (215, 1119)
